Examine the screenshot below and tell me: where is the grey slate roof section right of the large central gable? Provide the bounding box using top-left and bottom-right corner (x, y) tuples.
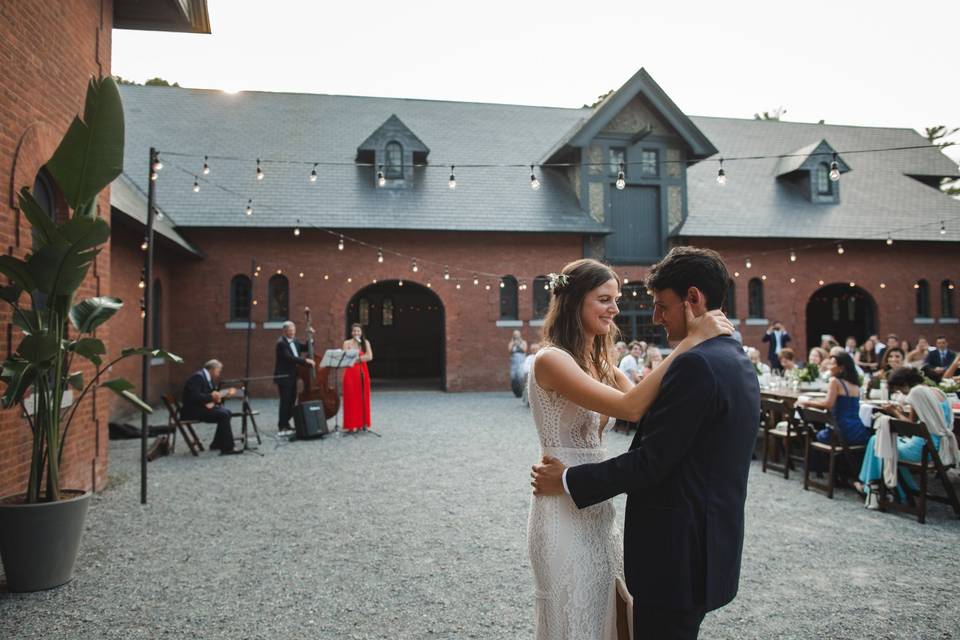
(679, 116), (960, 242)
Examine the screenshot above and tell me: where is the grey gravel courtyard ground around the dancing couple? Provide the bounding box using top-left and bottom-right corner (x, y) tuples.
(0, 392), (960, 640)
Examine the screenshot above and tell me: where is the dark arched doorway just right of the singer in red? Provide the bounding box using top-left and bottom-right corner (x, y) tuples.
(344, 280), (446, 389)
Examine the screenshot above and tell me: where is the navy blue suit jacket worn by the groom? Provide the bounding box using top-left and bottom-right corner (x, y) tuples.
(567, 336), (760, 611)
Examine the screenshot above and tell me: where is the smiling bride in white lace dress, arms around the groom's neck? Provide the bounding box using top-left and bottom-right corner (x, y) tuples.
(527, 259), (733, 640)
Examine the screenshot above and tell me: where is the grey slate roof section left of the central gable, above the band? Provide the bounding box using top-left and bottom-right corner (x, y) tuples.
(114, 85), (607, 233)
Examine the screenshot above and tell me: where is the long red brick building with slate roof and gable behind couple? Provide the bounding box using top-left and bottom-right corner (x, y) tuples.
(105, 70), (960, 416)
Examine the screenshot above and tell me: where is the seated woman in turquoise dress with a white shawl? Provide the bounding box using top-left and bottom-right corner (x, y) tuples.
(854, 367), (953, 507)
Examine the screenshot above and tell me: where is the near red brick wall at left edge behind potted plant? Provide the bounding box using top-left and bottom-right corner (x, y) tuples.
(0, 0), (113, 496)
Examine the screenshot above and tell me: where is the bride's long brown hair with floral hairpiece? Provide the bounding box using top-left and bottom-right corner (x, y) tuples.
(543, 258), (620, 387)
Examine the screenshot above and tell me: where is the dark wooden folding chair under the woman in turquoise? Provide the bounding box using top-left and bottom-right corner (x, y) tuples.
(880, 420), (960, 524)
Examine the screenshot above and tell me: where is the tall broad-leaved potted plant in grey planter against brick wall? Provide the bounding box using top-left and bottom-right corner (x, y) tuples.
(0, 78), (180, 591)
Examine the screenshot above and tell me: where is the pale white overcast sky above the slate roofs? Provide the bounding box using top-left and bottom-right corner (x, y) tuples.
(113, 0), (960, 158)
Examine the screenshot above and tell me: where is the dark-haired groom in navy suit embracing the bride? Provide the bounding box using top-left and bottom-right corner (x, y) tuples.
(534, 247), (760, 640)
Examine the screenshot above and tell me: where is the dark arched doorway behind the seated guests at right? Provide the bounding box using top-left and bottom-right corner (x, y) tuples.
(807, 284), (877, 349)
